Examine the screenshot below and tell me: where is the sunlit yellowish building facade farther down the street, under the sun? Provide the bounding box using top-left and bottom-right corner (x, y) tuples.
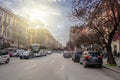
(28, 28), (62, 49)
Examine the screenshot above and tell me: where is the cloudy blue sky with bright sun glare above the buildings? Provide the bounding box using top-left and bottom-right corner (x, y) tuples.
(0, 0), (72, 45)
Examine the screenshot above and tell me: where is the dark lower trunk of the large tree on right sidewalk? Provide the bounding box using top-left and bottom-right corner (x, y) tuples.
(106, 45), (116, 65)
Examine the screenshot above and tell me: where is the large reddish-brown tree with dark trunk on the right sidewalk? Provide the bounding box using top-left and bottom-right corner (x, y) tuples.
(72, 0), (120, 64)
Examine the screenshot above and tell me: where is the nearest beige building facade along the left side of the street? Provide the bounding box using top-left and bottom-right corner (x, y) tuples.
(0, 6), (28, 48)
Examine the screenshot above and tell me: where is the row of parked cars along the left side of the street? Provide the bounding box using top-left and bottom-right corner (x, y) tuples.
(0, 48), (52, 63)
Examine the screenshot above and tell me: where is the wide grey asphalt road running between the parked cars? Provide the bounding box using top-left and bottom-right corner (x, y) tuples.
(0, 53), (114, 80)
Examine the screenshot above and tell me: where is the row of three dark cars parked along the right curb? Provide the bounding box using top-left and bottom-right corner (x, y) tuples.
(63, 51), (103, 68)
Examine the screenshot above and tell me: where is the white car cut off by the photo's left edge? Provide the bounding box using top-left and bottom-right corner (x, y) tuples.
(0, 50), (10, 63)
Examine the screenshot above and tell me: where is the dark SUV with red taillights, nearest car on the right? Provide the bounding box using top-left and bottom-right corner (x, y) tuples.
(80, 51), (103, 67)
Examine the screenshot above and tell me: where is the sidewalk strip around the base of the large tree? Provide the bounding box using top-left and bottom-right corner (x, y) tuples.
(103, 58), (120, 74)
